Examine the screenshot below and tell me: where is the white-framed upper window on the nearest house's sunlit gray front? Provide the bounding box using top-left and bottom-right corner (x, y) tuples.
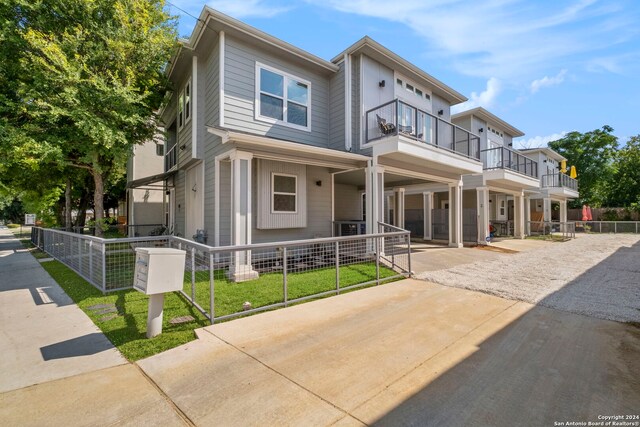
(256, 63), (311, 131)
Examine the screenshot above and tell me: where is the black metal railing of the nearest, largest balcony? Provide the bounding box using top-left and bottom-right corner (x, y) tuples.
(365, 99), (480, 160)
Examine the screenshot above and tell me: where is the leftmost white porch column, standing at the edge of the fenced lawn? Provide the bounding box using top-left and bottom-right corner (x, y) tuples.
(228, 151), (258, 282)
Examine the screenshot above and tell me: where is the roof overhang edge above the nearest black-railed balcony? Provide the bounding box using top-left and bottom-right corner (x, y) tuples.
(331, 36), (467, 105)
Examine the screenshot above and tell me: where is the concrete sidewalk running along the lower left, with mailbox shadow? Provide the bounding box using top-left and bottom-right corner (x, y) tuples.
(0, 230), (185, 426)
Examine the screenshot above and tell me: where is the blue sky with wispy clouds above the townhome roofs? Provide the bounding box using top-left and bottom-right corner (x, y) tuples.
(169, 0), (640, 147)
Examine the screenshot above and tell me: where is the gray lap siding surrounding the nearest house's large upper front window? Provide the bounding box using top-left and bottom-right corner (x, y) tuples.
(224, 36), (329, 147)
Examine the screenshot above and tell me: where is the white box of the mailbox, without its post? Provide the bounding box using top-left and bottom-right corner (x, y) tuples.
(133, 248), (186, 295)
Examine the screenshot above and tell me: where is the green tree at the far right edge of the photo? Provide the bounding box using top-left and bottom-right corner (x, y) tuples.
(608, 135), (640, 207)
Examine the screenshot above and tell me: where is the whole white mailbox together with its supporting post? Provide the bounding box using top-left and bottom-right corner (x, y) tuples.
(133, 248), (186, 338)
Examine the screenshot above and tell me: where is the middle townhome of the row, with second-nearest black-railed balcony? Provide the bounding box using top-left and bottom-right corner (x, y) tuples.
(452, 107), (540, 244)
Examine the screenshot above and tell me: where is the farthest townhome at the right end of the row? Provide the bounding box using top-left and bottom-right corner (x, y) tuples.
(520, 147), (579, 227)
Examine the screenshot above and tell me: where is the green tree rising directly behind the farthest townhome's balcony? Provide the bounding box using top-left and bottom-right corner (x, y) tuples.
(549, 125), (618, 208)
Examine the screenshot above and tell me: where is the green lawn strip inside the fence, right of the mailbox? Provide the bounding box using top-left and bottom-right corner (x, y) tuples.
(183, 263), (397, 317)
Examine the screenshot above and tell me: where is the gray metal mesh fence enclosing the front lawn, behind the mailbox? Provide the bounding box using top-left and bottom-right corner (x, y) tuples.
(31, 223), (411, 322)
